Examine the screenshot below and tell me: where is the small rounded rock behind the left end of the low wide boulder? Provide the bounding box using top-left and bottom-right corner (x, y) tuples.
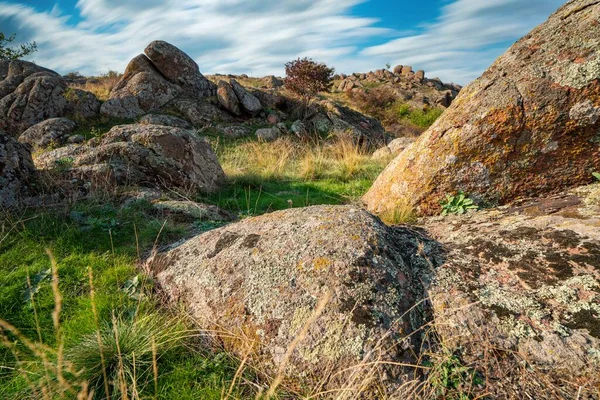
(19, 118), (76, 149)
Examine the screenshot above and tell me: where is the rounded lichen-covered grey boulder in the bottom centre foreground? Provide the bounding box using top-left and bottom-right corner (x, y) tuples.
(150, 206), (434, 393)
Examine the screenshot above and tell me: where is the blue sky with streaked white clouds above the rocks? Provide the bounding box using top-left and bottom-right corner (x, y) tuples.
(0, 0), (566, 84)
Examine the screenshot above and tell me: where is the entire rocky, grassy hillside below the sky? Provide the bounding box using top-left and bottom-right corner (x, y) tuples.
(0, 0), (600, 400)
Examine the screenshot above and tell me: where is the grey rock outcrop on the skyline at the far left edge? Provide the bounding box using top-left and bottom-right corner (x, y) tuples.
(0, 60), (100, 136)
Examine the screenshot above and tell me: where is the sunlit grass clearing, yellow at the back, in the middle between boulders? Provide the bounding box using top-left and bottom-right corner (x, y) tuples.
(200, 137), (385, 215)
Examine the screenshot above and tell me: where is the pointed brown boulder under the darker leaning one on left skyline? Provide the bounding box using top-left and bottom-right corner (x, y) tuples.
(100, 54), (181, 119)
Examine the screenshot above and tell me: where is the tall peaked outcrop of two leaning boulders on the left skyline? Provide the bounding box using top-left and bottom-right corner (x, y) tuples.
(101, 41), (216, 119)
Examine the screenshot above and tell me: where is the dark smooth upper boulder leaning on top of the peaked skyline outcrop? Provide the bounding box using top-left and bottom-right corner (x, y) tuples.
(144, 40), (216, 98)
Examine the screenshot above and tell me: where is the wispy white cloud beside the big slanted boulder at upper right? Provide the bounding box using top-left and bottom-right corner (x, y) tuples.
(361, 0), (564, 84)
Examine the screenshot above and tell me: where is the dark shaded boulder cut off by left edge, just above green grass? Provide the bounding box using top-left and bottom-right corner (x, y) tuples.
(0, 130), (35, 208)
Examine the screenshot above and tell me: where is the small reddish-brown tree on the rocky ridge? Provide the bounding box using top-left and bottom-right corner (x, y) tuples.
(285, 58), (334, 115)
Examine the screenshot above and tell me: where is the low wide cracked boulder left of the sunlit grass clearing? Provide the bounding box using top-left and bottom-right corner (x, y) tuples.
(36, 124), (225, 192)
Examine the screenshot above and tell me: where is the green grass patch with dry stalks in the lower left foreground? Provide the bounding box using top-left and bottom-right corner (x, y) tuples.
(0, 202), (251, 399)
